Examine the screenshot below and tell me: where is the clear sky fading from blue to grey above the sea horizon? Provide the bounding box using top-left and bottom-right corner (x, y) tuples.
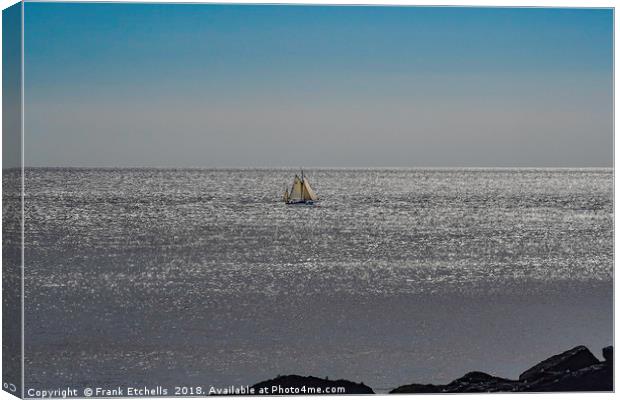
(24, 2), (613, 168)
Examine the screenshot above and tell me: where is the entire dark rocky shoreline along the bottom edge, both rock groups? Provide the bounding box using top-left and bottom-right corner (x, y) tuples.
(247, 346), (613, 395)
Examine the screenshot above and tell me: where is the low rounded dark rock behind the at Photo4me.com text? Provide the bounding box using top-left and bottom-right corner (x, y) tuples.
(252, 375), (375, 395)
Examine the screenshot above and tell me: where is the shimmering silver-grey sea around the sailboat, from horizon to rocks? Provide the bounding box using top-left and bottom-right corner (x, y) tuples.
(25, 169), (613, 391)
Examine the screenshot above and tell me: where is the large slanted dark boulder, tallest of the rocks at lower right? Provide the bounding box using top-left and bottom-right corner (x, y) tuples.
(519, 346), (599, 381)
